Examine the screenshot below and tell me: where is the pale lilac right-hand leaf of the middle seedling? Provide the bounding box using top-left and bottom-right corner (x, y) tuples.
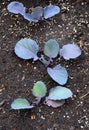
(60, 44), (81, 60)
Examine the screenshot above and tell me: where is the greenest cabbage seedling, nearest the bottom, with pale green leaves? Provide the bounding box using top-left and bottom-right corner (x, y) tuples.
(11, 81), (73, 110)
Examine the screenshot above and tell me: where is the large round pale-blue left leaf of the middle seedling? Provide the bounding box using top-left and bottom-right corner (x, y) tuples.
(15, 38), (39, 61)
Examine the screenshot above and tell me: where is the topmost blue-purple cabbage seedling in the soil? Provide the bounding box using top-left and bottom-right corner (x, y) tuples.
(7, 1), (60, 23)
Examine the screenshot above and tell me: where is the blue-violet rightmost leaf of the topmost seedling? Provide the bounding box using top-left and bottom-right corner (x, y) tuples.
(44, 5), (60, 19)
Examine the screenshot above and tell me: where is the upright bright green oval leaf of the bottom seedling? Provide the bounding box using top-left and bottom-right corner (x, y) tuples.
(32, 81), (47, 97)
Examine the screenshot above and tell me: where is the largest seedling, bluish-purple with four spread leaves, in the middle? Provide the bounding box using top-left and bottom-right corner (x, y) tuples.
(15, 38), (81, 78)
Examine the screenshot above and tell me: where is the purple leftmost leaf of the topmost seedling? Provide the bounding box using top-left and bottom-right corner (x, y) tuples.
(7, 1), (26, 15)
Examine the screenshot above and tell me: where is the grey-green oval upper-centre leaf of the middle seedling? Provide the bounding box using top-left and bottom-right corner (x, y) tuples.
(44, 39), (59, 58)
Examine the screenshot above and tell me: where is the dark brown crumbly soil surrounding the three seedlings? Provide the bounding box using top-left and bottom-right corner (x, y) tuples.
(0, 0), (89, 130)
